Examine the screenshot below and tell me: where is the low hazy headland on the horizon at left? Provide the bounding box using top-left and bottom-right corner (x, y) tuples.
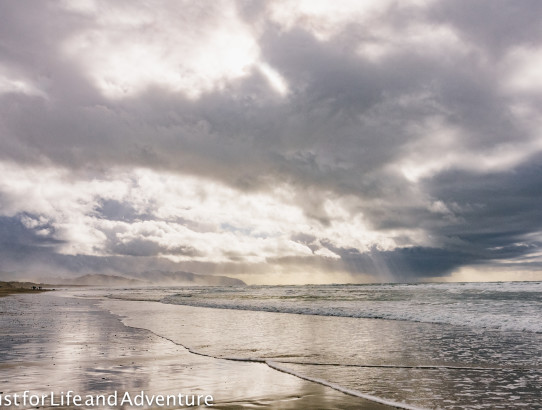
(40, 270), (246, 286)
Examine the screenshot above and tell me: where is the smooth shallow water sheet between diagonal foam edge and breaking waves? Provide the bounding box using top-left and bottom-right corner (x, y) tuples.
(102, 286), (542, 409)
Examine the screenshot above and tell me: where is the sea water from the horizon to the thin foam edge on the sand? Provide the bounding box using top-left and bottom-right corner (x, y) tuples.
(106, 282), (542, 409)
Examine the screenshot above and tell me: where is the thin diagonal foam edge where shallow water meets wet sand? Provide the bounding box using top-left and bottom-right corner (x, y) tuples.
(119, 324), (425, 410)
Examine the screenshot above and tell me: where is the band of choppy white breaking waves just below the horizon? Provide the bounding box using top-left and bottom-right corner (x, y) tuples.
(162, 282), (542, 333)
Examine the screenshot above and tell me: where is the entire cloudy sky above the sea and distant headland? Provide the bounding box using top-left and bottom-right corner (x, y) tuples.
(0, 0), (542, 284)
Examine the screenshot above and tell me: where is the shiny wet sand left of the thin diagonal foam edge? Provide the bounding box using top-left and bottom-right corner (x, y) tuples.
(0, 292), (390, 409)
